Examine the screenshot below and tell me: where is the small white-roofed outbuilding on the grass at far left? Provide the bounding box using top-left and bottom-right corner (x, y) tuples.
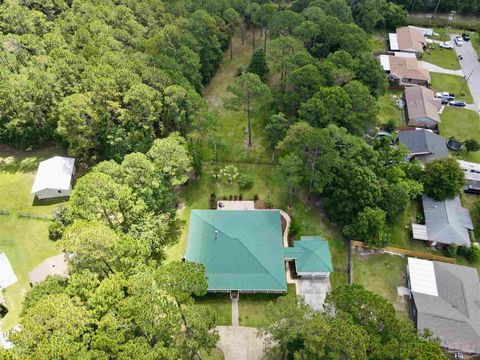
(32, 156), (75, 200)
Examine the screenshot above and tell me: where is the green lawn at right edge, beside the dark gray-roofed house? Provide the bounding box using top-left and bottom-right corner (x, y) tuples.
(440, 107), (480, 162)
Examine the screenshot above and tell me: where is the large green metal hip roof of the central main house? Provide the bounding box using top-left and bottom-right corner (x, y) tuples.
(185, 210), (287, 291)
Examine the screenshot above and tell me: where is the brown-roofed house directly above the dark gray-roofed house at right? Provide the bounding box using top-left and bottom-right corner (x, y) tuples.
(404, 85), (442, 129)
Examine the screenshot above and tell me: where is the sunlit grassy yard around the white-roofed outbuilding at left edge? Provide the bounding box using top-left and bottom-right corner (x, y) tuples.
(0, 146), (63, 329)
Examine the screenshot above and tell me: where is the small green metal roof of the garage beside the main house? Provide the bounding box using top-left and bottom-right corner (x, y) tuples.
(284, 236), (333, 273)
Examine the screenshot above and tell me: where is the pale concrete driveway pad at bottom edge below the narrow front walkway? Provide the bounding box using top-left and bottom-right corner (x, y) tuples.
(216, 326), (265, 360)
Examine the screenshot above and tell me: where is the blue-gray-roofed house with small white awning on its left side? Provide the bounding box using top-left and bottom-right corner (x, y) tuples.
(412, 194), (473, 247)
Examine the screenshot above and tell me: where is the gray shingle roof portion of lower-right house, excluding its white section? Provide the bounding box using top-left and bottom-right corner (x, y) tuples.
(412, 261), (480, 353)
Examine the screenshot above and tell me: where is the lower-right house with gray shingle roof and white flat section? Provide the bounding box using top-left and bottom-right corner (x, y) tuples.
(407, 258), (480, 354)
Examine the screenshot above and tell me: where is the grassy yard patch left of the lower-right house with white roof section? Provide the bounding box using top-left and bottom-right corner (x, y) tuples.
(353, 253), (407, 316)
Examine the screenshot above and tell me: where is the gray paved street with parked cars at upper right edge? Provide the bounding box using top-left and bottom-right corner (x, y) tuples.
(451, 35), (480, 110)
